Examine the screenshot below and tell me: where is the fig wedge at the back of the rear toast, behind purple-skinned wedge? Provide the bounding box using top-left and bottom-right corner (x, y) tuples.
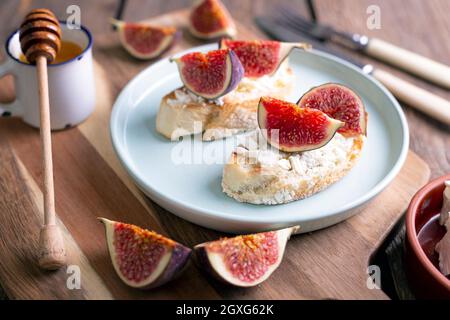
(220, 39), (311, 78)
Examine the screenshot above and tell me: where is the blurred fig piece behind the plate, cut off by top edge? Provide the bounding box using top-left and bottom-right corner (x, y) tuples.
(188, 0), (236, 39)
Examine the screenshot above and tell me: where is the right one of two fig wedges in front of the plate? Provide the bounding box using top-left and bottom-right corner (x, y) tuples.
(194, 226), (300, 287)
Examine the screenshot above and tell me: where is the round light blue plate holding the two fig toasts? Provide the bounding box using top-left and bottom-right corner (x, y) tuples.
(111, 45), (409, 233)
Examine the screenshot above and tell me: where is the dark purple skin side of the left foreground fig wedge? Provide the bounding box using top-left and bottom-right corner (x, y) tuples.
(146, 244), (192, 289)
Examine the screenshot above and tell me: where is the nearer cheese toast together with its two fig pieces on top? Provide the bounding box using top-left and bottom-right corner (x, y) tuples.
(222, 84), (367, 204)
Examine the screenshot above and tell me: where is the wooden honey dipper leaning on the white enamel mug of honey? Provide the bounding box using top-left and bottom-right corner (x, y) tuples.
(20, 9), (66, 270)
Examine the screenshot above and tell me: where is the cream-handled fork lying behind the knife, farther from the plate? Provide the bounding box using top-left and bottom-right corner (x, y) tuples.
(275, 7), (450, 89)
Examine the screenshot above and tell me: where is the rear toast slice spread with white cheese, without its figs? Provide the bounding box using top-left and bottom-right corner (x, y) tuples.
(156, 61), (295, 141)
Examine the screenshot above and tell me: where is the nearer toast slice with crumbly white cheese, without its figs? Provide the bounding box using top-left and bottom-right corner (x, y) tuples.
(222, 132), (365, 204)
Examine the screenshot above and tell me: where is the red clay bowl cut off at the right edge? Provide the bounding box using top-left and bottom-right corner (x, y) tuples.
(406, 174), (450, 299)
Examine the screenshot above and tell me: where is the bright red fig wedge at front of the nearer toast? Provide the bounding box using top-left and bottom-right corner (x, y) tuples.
(258, 97), (344, 152)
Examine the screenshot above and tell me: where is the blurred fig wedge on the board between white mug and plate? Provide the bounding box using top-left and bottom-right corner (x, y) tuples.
(111, 19), (180, 60)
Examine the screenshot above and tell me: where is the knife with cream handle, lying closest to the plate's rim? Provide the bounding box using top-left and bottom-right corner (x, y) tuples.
(255, 17), (450, 126)
